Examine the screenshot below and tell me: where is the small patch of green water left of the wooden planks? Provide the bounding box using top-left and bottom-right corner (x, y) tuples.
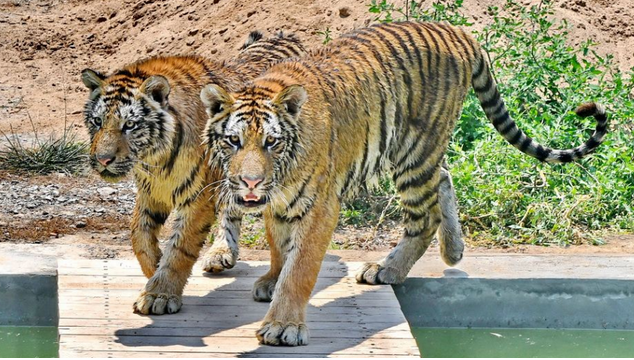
(0, 326), (59, 358)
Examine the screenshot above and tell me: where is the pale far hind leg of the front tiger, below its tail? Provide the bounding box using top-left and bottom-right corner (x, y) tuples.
(437, 162), (464, 266)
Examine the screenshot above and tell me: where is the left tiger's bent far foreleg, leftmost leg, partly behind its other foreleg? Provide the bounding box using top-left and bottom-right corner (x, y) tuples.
(130, 192), (172, 279)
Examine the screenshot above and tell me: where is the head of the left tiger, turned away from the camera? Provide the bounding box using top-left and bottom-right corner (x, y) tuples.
(81, 69), (174, 181)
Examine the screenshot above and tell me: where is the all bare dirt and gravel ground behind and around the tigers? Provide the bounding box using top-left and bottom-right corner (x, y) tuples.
(0, 0), (634, 258)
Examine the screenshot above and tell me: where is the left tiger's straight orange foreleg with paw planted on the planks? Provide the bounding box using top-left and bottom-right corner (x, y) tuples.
(133, 197), (215, 315)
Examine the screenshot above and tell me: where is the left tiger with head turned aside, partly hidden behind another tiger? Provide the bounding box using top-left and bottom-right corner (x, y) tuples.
(82, 32), (304, 314)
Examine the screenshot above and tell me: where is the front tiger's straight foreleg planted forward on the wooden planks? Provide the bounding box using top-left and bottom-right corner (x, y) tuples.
(256, 196), (339, 346)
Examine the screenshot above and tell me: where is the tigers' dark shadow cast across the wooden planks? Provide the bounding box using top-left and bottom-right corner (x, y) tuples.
(115, 254), (402, 357)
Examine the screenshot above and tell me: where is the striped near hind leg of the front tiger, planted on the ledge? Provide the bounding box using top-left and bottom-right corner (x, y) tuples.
(356, 166), (442, 284)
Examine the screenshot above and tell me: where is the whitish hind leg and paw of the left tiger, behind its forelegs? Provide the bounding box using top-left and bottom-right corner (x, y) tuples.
(202, 210), (242, 273)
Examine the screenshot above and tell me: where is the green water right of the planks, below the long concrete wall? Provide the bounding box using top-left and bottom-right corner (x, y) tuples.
(412, 328), (634, 358)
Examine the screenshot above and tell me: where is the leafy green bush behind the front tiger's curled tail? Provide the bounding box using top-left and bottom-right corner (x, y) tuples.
(369, 0), (634, 245)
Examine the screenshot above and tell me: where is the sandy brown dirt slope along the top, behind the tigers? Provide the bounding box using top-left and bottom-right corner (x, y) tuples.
(0, 0), (634, 138)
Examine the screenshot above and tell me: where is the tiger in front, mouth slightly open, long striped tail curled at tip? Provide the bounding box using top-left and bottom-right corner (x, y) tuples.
(200, 22), (607, 346)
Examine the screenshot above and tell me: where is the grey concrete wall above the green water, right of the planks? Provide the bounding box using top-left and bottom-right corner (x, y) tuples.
(394, 278), (634, 329)
